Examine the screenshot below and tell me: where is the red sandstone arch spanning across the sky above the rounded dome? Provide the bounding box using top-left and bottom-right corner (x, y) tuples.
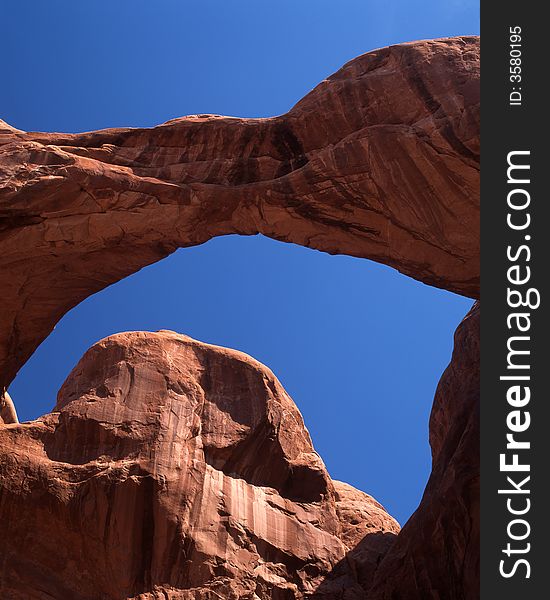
(0, 37), (479, 388)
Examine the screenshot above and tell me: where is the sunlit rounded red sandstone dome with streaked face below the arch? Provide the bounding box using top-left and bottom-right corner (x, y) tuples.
(0, 332), (399, 600)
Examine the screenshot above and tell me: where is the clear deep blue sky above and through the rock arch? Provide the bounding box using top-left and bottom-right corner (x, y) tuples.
(0, 0), (479, 523)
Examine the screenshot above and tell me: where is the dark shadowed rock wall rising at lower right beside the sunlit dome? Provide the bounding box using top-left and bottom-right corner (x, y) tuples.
(367, 304), (480, 600)
